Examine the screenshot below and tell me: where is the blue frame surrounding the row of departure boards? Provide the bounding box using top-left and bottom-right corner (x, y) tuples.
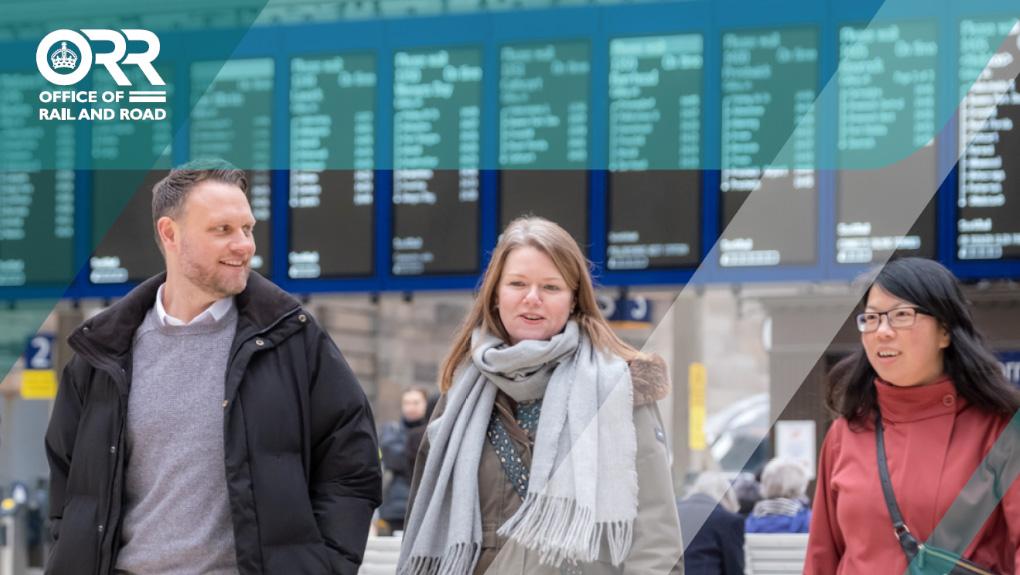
(0, 0), (1020, 300)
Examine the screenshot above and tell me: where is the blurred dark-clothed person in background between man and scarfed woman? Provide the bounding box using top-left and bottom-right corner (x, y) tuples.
(378, 385), (428, 534)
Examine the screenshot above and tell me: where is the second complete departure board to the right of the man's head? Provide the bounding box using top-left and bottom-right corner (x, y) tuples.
(391, 48), (481, 275)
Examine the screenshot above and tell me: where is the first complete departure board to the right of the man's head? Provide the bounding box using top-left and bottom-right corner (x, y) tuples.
(287, 54), (376, 279)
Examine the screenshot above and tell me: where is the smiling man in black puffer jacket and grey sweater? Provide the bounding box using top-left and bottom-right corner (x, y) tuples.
(46, 159), (381, 575)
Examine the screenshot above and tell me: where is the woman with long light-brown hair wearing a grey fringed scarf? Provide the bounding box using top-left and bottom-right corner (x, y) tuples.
(398, 217), (682, 575)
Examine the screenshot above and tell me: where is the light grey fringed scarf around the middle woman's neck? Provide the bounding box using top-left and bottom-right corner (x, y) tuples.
(397, 321), (638, 575)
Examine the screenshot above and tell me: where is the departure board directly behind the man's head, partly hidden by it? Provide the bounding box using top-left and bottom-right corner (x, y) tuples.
(190, 58), (273, 275)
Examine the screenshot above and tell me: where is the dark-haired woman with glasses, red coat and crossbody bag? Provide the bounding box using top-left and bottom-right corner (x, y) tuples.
(805, 258), (1020, 575)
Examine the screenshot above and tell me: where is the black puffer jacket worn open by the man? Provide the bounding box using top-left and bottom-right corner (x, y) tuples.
(46, 273), (381, 575)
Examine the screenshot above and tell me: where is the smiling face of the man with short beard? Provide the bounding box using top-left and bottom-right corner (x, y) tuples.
(167, 180), (255, 300)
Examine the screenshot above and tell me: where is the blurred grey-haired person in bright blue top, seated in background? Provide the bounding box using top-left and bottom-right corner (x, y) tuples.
(745, 459), (811, 533)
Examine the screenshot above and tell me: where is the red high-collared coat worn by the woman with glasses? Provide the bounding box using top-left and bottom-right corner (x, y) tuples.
(804, 379), (1020, 575)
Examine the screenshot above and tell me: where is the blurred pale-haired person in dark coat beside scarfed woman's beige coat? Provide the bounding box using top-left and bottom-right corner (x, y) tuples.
(677, 471), (744, 575)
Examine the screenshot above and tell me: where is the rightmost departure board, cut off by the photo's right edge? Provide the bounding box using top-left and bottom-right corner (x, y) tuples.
(956, 18), (1020, 260)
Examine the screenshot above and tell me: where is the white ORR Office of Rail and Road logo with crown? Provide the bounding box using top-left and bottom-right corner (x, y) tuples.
(36, 29), (166, 120)
